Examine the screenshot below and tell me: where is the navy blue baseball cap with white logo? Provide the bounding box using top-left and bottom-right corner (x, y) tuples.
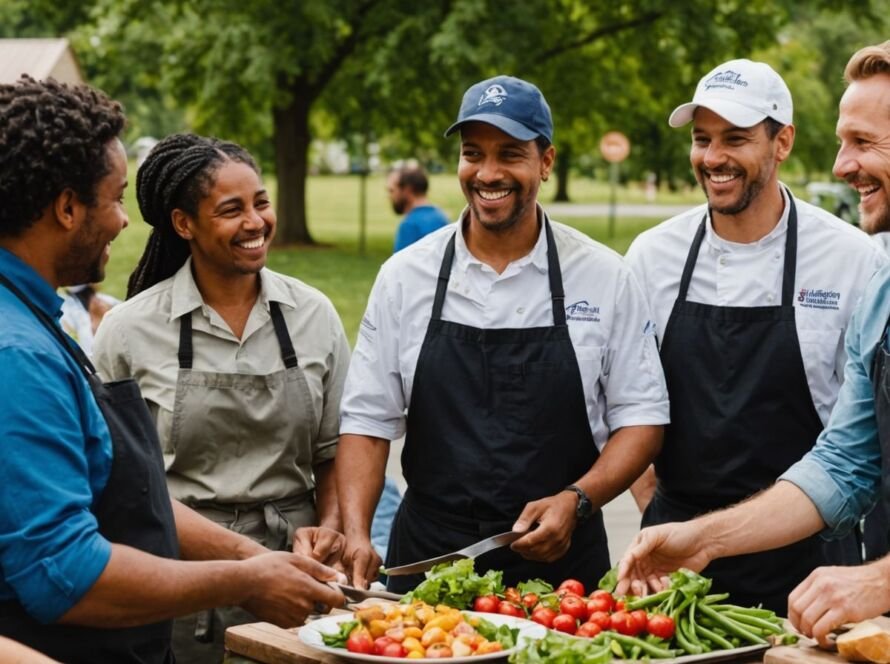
(445, 76), (553, 143)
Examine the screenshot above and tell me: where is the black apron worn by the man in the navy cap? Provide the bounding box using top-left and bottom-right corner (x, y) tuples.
(386, 217), (609, 592)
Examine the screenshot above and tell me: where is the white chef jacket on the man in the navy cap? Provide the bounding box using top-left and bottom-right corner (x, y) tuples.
(340, 211), (670, 449)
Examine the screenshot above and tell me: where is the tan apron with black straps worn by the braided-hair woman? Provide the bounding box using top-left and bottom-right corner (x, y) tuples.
(167, 302), (318, 663)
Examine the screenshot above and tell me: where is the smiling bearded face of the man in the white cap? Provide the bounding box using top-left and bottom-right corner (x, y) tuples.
(689, 106), (794, 215)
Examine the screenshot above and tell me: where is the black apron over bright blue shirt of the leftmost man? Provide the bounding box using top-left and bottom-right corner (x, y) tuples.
(0, 275), (179, 664)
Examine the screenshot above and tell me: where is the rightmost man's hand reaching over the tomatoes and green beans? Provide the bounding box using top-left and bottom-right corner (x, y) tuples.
(615, 521), (711, 597)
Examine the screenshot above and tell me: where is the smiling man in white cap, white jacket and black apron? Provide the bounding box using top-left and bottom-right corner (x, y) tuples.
(627, 60), (885, 613)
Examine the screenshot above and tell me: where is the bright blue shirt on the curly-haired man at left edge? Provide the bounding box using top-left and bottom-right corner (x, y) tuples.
(0, 249), (113, 623)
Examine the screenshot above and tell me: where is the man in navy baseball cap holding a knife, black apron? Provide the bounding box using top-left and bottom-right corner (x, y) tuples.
(336, 76), (668, 591)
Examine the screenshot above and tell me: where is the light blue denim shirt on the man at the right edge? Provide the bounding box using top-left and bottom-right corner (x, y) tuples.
(779, 266), (890, 538)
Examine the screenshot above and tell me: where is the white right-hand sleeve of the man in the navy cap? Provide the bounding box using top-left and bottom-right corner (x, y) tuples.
(601, 269), (670, 431)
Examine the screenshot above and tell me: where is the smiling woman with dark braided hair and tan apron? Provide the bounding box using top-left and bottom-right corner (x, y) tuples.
(94, 134), (349, 662)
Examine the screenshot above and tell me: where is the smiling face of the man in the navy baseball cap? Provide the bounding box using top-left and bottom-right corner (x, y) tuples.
(457, 122), (556, 232)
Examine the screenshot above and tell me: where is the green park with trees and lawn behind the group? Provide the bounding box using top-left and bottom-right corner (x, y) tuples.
(0, 0), (890, 558)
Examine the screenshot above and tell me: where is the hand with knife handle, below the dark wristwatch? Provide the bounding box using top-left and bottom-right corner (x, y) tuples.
(510, 491), (577, 563)
